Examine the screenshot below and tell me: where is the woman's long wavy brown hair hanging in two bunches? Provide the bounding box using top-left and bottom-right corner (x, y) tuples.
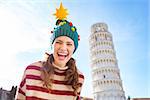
(41, 54), (80, 95)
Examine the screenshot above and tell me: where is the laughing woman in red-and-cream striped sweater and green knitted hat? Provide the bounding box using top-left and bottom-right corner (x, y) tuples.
(17, 2), (84, 100)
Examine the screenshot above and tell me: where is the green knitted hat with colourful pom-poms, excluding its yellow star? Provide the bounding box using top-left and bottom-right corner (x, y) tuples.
(51, 20), (79, 52)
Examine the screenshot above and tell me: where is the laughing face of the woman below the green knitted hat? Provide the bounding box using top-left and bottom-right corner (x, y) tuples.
(53, 36), (75, 67)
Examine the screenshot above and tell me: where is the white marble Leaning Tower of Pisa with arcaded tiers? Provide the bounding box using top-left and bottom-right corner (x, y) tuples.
(89, 23), (126, 100)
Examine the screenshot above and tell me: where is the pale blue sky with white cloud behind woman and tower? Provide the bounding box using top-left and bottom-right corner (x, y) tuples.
(0, 0), (150, 98)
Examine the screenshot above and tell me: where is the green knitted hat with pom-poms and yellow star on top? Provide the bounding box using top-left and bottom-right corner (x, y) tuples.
(51, 3), (79, 52)
